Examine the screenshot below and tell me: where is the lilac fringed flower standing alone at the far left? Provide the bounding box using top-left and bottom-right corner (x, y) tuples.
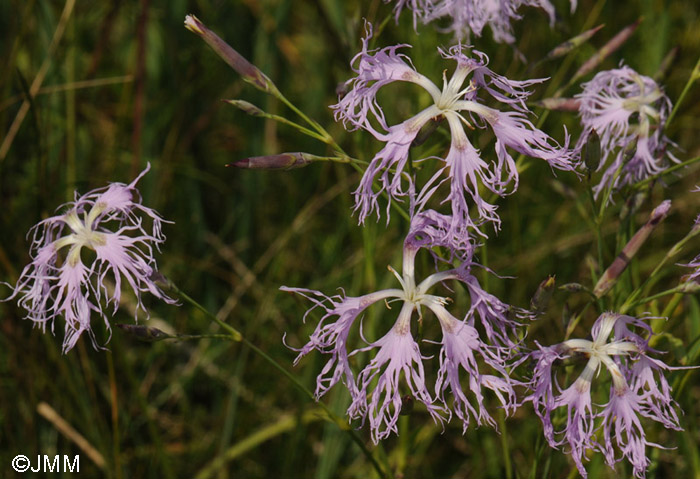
(7, 165), (175, 353)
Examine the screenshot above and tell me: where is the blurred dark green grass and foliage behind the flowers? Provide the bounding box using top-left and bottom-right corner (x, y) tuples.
(0, 0), (700, 479)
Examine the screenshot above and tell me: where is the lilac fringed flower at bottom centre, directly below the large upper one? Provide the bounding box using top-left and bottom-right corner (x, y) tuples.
(280, 210), (522, 443)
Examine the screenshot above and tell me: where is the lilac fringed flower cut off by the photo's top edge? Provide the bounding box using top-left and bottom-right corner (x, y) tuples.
(386, 0), (577, 43)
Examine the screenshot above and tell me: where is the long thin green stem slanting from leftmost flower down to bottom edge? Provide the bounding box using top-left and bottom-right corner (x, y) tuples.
(171, 284), (390, 479)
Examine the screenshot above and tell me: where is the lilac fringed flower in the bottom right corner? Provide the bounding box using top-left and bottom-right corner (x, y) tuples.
(527, 313), (680, 478)
